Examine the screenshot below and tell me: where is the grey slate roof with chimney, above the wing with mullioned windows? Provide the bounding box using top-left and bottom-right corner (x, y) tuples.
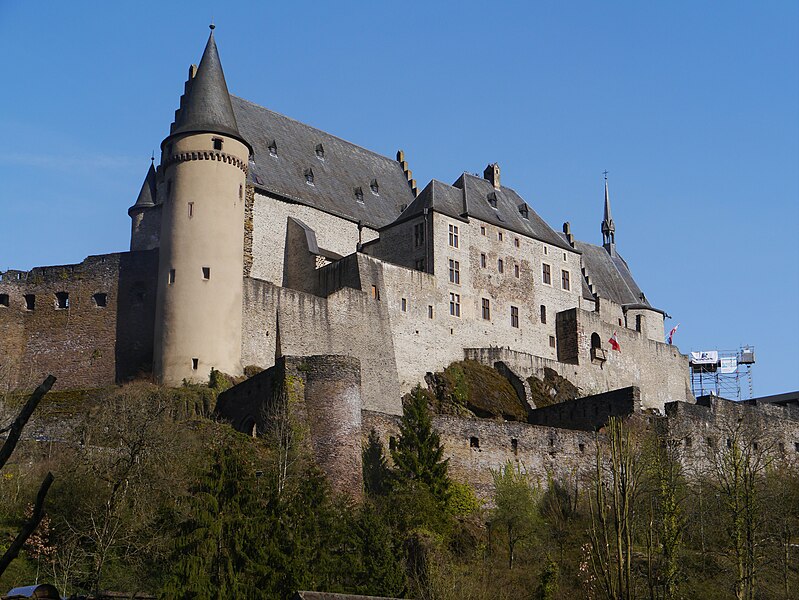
(399, 173), (574, 251)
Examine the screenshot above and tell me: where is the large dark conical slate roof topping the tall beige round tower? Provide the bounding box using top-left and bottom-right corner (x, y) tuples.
(170, 26), (243, 141)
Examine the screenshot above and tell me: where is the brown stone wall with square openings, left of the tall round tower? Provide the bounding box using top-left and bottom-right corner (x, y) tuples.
(0, 251), (158, 389)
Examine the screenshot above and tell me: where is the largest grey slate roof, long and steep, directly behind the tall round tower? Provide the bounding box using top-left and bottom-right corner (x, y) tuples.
(231, 96), (414, 229)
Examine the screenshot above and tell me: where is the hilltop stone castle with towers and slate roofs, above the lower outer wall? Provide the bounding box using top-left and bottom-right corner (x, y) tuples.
(0, 27), (693, 414)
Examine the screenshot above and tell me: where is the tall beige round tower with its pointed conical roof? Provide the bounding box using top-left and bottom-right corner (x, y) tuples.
(153, 26), (252, 385)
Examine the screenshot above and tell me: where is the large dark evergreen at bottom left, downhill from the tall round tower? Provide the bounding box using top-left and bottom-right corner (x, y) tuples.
(162, 446), (259, 600)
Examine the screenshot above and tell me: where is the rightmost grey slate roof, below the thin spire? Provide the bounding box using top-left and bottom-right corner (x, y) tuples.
(559, 234), (659, 310)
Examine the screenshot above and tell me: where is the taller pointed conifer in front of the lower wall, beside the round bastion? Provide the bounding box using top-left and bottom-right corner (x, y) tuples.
(391, 386), (449, 504)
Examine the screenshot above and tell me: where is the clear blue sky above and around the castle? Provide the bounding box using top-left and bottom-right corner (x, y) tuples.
(0, 0), (799, 395)
